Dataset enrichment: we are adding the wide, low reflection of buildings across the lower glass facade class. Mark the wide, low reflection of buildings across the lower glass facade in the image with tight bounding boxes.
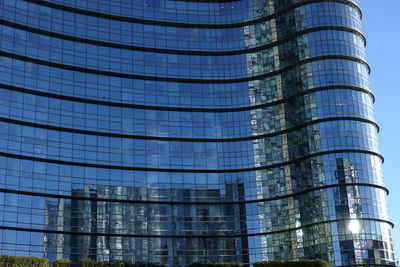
[44,183,248,264]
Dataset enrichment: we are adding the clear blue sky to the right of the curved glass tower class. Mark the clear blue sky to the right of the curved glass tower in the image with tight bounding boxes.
[360,0,400,260]
